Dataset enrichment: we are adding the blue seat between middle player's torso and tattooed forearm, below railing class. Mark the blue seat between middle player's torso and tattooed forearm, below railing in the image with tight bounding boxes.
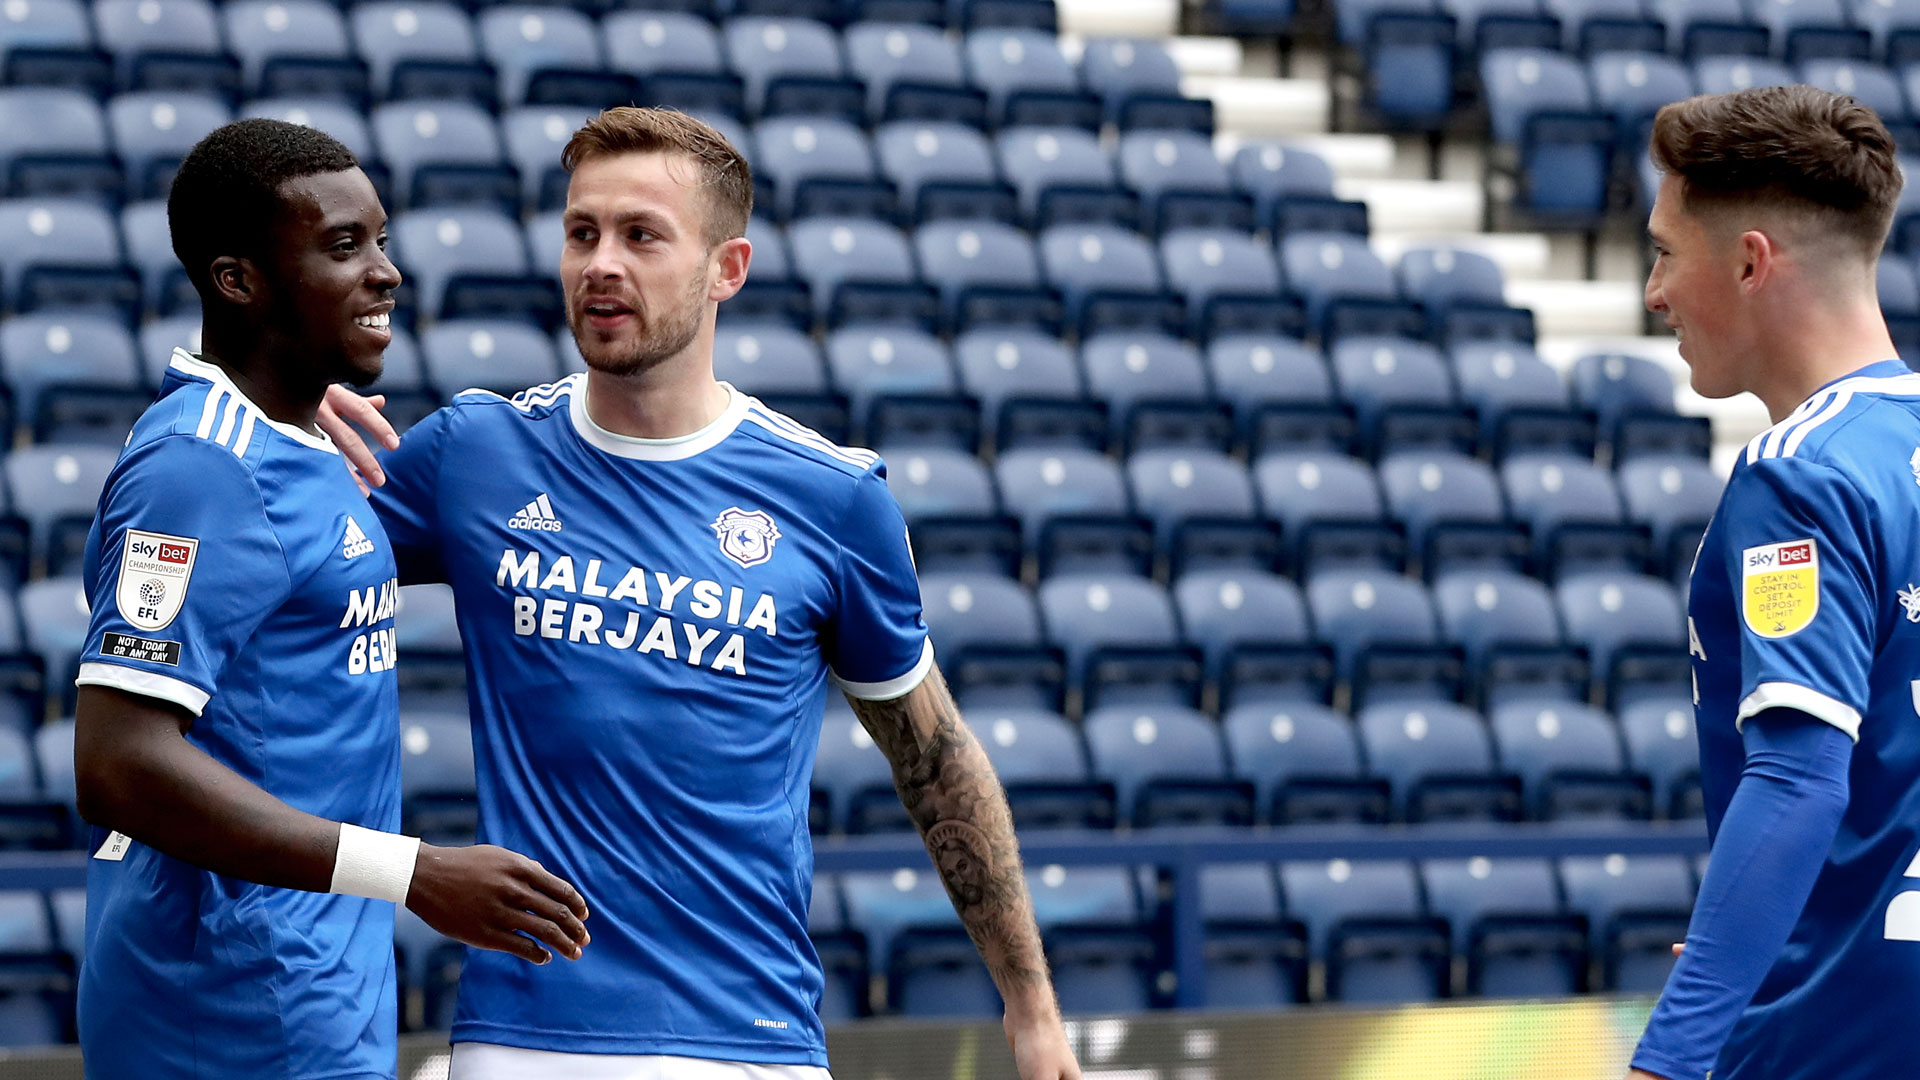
[841,867,1002,1017]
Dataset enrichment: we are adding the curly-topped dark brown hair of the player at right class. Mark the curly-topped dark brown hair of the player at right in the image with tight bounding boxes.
[1649,86,1903,259]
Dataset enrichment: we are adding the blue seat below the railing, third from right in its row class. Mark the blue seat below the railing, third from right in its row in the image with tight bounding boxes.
[1281,859,1450,1005]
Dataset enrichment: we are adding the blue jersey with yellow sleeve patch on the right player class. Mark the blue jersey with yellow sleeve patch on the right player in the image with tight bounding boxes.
[1688,361,1920,1080]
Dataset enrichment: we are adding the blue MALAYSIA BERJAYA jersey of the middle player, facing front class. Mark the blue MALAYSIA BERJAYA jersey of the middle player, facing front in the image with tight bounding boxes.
[374,375,933,1065]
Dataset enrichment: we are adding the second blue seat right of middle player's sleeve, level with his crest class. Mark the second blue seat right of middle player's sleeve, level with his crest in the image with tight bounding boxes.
[993,446,1154,578]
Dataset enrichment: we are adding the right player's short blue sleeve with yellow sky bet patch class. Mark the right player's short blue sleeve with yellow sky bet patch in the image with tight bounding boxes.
[1720,457,1880,738]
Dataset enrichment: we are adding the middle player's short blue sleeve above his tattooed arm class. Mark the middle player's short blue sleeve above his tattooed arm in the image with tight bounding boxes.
[824,463,933,701]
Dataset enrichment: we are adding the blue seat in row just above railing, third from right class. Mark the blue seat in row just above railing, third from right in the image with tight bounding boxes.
[1354,701,1523,822]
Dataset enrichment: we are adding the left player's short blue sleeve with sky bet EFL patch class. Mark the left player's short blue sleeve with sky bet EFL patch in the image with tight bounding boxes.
[75,436,292,717]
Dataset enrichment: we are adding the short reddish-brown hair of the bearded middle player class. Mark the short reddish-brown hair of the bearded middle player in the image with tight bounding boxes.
[561,106,753,246]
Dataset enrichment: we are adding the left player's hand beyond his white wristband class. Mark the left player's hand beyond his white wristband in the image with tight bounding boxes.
[407,844,591,965]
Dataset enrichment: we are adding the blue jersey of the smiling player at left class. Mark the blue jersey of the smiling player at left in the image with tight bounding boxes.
[79,352,399,1080]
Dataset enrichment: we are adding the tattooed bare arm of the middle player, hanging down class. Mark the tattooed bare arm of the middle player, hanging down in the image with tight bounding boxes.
[849,667,1079,1080]
